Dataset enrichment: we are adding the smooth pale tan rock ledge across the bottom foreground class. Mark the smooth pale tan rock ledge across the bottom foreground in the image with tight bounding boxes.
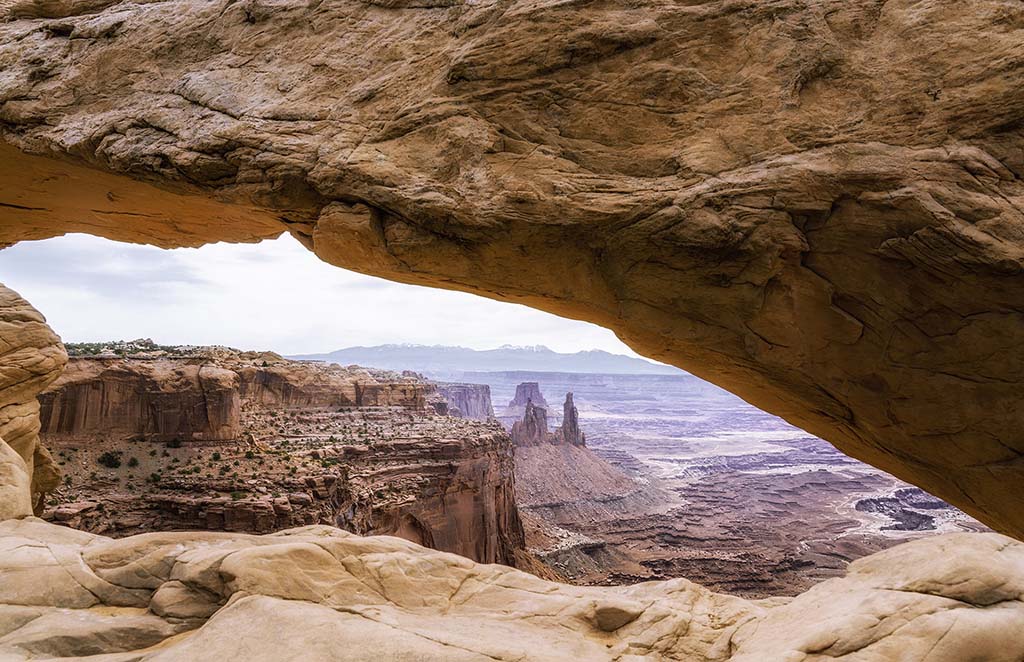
[0,519,1024,662]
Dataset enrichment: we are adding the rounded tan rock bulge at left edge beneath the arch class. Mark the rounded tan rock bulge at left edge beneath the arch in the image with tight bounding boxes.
[0,284,68,520]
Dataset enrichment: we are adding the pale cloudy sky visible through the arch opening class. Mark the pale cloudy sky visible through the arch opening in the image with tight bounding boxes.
[0,235,637,356]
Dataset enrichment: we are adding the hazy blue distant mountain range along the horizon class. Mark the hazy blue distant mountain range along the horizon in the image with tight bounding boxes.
[289,344,684,375]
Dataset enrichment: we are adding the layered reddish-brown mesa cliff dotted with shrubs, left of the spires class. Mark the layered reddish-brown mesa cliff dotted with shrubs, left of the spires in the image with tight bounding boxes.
[40,349,524,564]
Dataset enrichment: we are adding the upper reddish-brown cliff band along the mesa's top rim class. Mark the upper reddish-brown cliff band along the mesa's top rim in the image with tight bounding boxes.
[39,349,434,442]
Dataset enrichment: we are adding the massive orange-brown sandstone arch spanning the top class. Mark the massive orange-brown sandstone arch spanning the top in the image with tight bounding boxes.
[0,0,1024,537]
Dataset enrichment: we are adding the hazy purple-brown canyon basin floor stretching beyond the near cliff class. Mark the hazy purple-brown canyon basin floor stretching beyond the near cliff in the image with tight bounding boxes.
[491,371,987,598]
